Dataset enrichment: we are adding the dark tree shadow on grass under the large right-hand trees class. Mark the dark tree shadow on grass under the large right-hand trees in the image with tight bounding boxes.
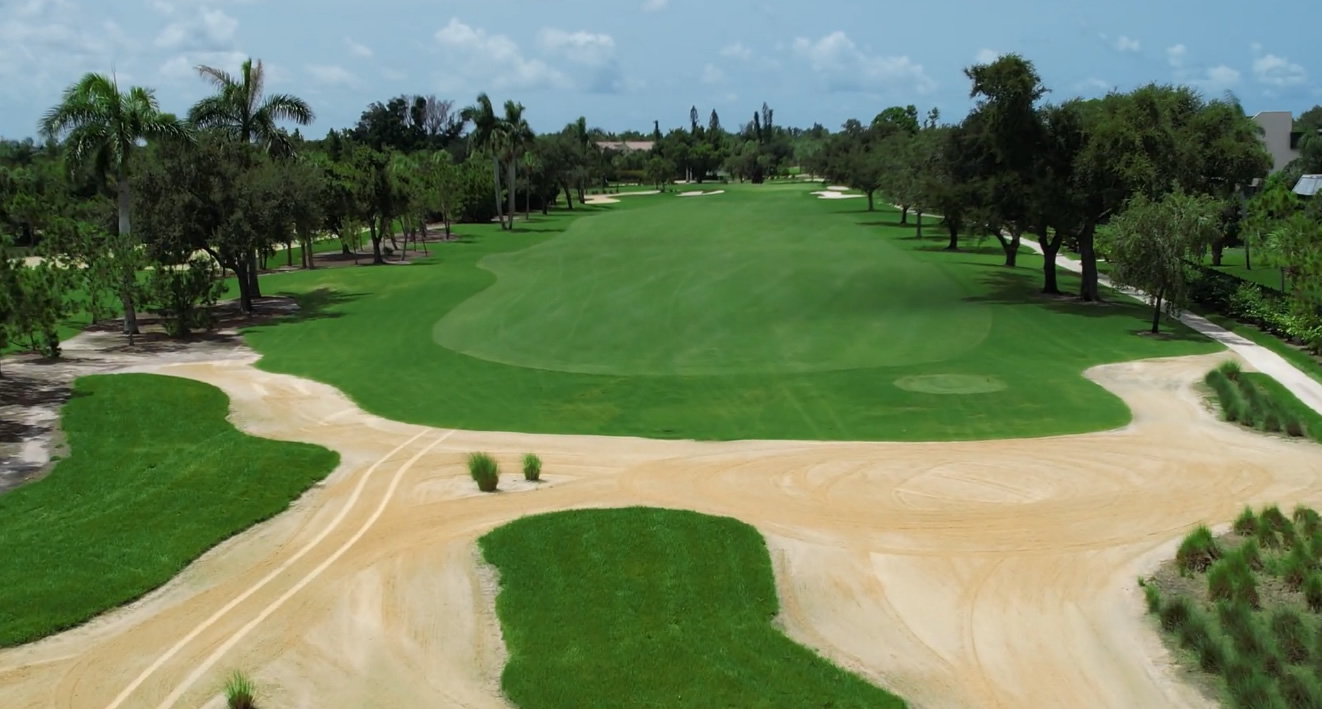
[964,266,1206,343]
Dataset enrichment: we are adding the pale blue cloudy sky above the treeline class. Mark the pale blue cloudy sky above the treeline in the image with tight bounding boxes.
[0,0,1322,138]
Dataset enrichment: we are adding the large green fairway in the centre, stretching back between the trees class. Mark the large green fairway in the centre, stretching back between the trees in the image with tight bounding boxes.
[240,183,1219,440]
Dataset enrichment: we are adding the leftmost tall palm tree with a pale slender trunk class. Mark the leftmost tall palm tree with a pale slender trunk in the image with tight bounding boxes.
[38,73,189,335]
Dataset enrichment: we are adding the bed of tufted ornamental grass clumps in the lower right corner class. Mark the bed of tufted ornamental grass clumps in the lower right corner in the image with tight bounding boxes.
[1140,507,1322,709]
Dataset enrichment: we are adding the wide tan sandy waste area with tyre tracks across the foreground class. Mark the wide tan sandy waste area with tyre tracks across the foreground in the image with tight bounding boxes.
[0,346,1322,709]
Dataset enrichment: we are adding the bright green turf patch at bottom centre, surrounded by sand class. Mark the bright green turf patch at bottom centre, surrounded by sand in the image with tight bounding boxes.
[480,508,904,709]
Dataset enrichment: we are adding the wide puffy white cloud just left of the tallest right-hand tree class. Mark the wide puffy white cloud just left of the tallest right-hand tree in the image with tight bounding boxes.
[792,30,936,94]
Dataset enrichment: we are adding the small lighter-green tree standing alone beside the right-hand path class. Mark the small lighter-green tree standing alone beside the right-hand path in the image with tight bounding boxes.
[1107,190,1222,333]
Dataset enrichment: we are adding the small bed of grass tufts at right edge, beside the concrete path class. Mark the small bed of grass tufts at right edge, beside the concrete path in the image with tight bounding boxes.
[1203,361,1322,440]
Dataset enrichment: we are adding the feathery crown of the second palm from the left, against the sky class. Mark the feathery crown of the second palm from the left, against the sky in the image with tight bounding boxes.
[188,60,316,153]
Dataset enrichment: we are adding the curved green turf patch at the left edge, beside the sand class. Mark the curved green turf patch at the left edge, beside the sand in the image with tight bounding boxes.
[0,374,338,647]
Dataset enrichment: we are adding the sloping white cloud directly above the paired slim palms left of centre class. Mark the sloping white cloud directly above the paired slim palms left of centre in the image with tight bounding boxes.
[435,17,570,90]
